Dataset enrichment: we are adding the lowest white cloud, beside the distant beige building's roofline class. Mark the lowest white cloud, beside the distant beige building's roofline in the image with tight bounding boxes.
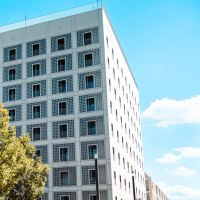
[157,182,200,200]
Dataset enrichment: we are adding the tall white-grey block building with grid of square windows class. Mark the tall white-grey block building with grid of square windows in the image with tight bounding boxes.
[0,4,146,200]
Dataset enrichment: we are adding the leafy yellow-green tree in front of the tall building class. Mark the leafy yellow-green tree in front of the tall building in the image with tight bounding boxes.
[0,104,49,200]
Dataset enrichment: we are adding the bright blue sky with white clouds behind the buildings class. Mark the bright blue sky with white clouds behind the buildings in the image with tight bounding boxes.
[0,0,200,200]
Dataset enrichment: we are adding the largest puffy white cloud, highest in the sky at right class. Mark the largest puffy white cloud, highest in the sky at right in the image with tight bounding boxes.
[142,95,200,127]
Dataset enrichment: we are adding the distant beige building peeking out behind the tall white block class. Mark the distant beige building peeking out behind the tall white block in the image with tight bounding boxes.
[145,173,169,200]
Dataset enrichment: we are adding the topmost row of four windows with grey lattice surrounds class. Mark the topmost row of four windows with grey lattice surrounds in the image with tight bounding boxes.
[4,27,99,62]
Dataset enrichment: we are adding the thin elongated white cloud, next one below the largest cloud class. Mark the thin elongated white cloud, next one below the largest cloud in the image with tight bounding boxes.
[155,147,200,164]
